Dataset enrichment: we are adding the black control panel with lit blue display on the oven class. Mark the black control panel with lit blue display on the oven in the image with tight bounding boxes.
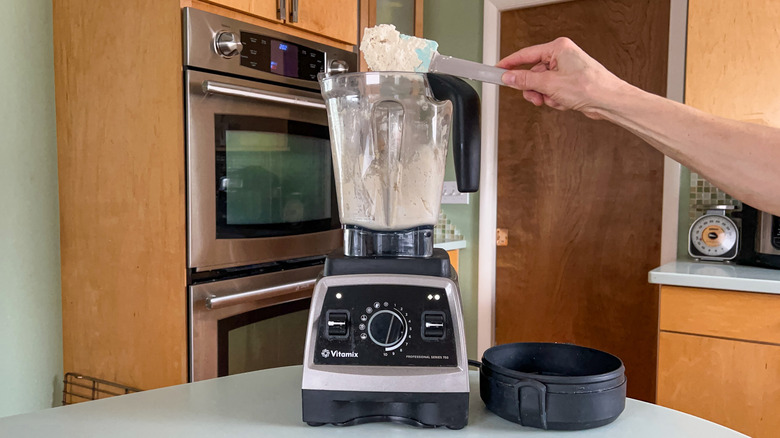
[241,32,325,81]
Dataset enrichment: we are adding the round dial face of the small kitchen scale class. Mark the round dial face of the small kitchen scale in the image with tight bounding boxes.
[689,214,738,260]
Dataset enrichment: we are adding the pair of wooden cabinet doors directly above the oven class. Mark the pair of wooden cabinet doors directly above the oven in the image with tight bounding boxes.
[197,0,358,44]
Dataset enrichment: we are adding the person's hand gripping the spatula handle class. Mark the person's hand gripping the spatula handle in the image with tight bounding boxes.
[497,38,628,119]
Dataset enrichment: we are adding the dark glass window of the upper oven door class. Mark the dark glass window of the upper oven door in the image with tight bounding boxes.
[215,114,339,239]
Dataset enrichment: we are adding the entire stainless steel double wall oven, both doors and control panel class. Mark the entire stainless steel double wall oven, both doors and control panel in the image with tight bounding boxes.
[183,8,357,381]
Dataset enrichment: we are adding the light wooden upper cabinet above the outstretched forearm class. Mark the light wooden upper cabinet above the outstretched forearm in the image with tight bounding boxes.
[685,0,780,126]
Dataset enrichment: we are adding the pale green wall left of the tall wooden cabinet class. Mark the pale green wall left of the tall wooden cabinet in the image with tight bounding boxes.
[0,0,62,416]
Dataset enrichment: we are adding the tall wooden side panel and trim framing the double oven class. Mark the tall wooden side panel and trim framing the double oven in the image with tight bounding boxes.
[53,0,358,396]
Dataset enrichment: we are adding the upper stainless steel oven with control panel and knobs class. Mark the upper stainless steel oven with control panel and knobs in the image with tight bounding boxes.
[184,8,357,271]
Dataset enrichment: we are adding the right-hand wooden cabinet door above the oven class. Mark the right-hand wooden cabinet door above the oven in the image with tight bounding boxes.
[287,0,358,44]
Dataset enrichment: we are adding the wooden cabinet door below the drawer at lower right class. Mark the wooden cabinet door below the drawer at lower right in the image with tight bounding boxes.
[656,331,780,438]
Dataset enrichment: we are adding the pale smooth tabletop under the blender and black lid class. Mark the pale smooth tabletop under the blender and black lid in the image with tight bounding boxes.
[0,366,744,438]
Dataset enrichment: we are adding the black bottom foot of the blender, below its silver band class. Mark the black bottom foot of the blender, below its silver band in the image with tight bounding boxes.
[302,390,469,429]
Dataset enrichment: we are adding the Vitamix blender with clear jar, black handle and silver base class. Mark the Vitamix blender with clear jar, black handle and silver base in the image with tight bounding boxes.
[302,72,480,429]
